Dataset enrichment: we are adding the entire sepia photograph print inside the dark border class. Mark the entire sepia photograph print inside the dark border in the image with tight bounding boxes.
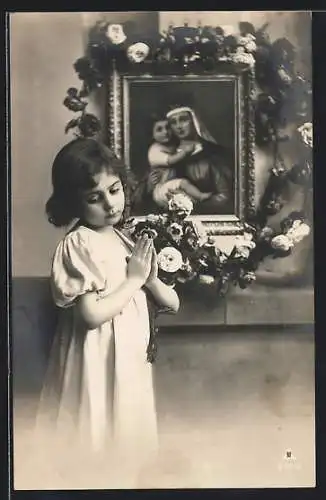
[7,10,316,491]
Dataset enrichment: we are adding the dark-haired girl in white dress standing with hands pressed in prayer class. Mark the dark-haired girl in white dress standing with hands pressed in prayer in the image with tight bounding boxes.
[38,138,179,488]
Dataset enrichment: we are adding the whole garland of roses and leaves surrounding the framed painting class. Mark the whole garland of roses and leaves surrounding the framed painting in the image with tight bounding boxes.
[64,21,312,295]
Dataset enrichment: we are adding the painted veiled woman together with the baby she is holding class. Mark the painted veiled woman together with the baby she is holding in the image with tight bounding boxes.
[129,81,235,215]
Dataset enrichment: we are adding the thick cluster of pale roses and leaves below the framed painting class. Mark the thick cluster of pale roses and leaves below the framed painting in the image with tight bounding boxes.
[123,193,310,297]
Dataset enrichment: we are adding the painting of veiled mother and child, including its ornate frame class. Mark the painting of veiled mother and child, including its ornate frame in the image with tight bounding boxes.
[109,65,255,234]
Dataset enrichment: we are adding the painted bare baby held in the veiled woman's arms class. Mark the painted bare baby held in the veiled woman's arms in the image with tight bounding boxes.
[148,118,212,209]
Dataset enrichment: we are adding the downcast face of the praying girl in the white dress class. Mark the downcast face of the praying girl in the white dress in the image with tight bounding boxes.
[80,170,125,229]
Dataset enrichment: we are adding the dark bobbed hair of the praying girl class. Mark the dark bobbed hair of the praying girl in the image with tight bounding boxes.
[45,138,131,227]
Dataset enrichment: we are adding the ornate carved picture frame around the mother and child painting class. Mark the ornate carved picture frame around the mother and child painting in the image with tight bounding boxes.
[108,63,256,235]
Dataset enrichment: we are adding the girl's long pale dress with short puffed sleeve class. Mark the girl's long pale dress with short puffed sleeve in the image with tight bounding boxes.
[36,226,157,486]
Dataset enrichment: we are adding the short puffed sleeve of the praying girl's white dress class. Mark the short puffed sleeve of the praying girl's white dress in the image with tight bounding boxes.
[51,231,106,307]
